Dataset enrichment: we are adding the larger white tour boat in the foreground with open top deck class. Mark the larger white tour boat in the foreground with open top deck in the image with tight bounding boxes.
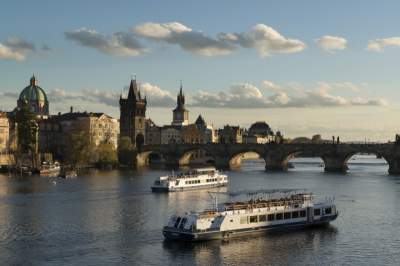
[163,190,338,241]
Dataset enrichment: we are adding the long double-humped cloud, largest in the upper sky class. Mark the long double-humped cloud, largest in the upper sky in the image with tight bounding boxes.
[133,22,306,57]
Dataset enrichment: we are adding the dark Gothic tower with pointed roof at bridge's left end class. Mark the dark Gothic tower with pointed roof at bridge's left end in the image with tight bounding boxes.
[119,78,147,147]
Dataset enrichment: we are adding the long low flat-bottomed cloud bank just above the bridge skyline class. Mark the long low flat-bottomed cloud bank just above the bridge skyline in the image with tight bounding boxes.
[192,80,388,109]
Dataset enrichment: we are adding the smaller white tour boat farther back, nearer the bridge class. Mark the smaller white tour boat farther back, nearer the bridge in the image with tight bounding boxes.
[151,167,228,192]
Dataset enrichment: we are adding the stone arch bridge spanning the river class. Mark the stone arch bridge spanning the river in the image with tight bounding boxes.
[135,143,400,174]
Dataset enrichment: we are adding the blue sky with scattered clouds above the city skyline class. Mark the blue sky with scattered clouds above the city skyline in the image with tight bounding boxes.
[0,0,400,141]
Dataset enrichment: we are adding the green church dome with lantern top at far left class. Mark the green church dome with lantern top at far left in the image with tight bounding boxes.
[17,76,49,115]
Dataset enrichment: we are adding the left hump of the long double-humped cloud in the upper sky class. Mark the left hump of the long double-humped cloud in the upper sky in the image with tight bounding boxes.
[133,22,235,56]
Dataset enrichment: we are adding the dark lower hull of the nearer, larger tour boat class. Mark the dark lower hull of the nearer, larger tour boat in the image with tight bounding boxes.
[163,214,338,242]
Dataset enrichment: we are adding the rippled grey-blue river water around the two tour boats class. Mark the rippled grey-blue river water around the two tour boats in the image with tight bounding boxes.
[0,155,400,265]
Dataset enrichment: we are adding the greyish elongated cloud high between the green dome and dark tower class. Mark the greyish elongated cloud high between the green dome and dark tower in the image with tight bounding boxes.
[64,28,147,56]
